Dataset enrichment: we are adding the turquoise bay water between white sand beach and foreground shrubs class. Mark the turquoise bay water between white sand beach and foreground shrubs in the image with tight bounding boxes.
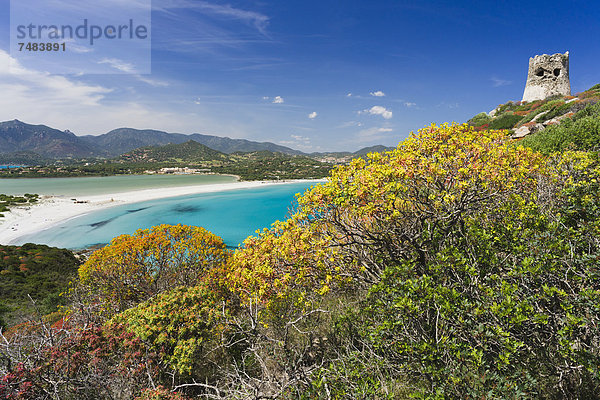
[14,182,314,249]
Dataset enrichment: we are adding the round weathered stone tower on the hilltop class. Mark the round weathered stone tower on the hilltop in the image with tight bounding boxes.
[523,51,571,101]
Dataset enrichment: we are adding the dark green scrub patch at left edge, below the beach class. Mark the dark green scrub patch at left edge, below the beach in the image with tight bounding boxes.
[0,243,80,328]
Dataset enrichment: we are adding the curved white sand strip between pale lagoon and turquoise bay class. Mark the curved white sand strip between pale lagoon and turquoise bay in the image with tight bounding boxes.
[0,179,326,245]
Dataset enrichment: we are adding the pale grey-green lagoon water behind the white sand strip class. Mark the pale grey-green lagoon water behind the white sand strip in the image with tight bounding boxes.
[0,175,236,196]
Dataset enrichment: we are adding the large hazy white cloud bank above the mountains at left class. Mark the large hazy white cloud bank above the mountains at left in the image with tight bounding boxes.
[0,50,218,135]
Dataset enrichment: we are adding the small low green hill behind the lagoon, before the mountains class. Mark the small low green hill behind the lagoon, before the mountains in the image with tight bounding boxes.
[119,140,228,163]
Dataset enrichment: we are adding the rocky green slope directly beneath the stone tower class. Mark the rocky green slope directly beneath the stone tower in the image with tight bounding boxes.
[467,84,600,138]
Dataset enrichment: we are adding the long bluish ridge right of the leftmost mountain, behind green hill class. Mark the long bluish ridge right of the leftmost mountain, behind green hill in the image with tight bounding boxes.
[81,128,302,157]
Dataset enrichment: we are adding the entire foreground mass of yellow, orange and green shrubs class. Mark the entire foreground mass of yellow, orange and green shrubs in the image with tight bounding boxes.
[0,121,600,399]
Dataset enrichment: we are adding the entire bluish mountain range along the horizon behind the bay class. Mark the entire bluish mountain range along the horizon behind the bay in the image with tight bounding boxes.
[0,119,389,163]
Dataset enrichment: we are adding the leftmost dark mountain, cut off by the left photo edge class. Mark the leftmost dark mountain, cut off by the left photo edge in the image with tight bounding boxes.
[0,119,97,158]
